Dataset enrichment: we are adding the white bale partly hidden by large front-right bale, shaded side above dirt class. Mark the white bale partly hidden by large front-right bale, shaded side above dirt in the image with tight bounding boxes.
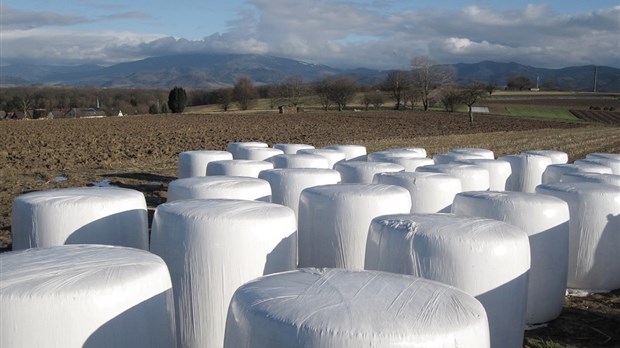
[452,192,569,324]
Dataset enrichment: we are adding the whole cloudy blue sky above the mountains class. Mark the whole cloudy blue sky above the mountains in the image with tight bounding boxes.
[0,0,620,69]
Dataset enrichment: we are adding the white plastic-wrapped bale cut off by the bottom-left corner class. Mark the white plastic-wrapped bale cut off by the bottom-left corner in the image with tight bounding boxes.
[0,244,176,348]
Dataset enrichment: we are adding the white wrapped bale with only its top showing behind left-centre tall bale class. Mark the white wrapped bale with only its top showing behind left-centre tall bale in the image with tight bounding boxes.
[168,176,271,202]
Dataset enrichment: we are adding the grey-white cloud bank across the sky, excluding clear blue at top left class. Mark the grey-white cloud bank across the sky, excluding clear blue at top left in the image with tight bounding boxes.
[2,0,620,69]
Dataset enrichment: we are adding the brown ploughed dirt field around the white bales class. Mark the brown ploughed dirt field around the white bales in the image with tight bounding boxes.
[0,112,620,347]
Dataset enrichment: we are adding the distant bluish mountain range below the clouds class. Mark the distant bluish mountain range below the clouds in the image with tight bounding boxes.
[0,54,620,92]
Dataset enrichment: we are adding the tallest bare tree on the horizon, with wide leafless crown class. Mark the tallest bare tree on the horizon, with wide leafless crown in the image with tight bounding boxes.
[411,56,456,110]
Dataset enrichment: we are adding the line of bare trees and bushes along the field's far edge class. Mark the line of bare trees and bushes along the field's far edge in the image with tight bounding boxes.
[0,56,532,122]
